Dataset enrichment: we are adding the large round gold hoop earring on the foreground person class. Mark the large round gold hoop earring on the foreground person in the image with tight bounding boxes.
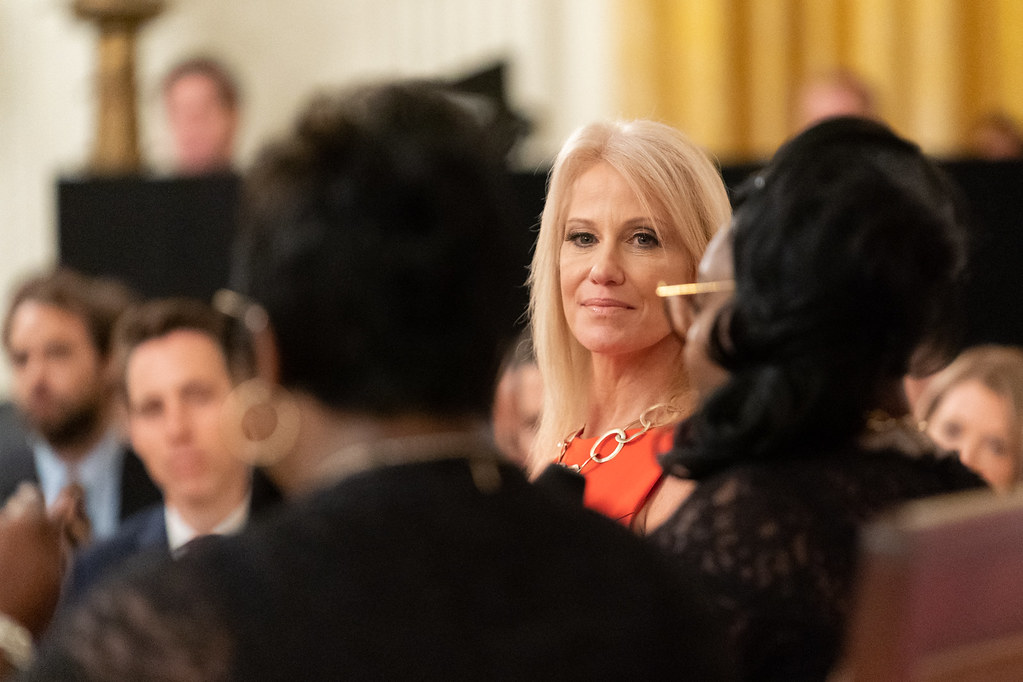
[221,378,301,466]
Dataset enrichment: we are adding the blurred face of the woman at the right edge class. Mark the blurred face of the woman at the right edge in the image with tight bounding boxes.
[927,379,1019,492]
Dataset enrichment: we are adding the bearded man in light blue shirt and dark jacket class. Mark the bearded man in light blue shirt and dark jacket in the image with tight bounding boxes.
[0,269,160,538]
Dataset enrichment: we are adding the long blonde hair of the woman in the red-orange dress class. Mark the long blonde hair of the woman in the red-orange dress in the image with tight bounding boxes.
[529,121,731,470]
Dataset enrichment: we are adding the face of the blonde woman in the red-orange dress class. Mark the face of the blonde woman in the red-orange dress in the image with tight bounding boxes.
[559,162,692,355]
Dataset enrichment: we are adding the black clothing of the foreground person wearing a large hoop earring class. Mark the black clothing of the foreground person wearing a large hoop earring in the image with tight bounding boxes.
[28,459,729,680]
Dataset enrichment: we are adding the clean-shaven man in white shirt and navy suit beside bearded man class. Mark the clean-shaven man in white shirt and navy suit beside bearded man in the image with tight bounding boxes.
[68,299,278,601]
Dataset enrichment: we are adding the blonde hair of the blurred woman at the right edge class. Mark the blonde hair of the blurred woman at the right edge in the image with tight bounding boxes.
[916,345,1023,482]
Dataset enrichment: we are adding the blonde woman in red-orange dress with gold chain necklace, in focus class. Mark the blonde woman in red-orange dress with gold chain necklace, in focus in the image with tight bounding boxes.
[530,121,730,526]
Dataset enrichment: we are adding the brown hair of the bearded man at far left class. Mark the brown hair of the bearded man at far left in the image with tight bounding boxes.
[3,267,134,359]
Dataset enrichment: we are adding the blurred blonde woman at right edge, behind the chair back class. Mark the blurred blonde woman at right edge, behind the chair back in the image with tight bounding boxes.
[917,346,1023,492]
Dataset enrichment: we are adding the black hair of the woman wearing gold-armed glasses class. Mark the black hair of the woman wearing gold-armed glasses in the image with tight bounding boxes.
[697,118,966,466]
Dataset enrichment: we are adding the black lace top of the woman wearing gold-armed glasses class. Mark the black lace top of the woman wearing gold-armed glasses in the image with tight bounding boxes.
[651,435,983,680]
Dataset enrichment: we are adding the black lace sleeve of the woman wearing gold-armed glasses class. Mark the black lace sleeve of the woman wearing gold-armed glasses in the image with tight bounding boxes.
[651,468,855,680]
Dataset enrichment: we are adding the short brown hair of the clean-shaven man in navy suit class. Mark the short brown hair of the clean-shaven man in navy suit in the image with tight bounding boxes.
[114,298,255,382]
